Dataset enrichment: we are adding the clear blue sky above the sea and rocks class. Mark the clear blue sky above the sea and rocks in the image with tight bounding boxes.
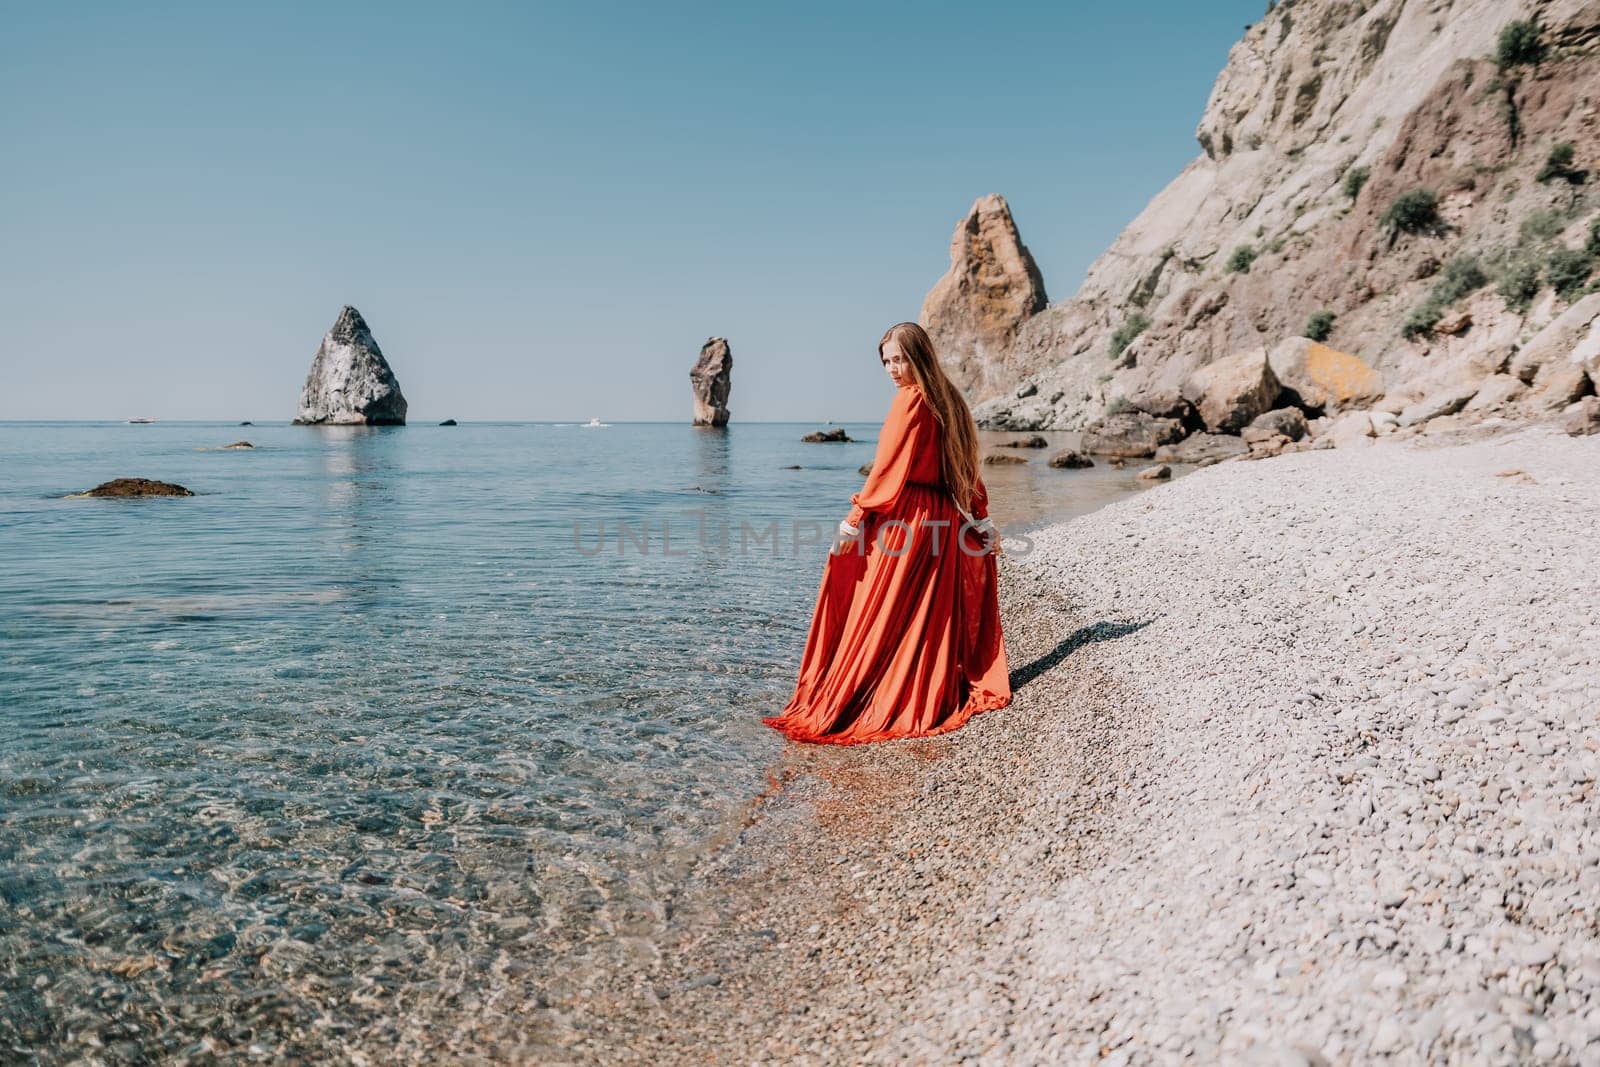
[0,0,1266,421]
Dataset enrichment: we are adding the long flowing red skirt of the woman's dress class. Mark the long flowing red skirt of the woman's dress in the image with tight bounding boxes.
[762,485,1011,744]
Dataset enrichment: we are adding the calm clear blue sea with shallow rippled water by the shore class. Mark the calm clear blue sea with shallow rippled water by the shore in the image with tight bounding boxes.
[0,422,1177,1062]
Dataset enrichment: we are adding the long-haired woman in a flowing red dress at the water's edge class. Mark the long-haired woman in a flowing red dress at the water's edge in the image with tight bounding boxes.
[763,323,1011,744]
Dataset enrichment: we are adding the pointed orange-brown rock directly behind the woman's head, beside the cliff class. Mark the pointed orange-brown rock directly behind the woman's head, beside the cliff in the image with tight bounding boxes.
[918,194,1050,400]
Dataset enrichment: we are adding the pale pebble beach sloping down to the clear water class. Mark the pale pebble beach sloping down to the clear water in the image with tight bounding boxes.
[540,427,1600,1064]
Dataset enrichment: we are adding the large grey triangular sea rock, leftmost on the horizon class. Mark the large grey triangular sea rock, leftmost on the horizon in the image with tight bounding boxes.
[294,304,406,426]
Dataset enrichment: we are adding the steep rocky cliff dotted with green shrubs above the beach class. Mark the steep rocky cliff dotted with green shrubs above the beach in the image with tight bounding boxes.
[947,0,1600,438]
